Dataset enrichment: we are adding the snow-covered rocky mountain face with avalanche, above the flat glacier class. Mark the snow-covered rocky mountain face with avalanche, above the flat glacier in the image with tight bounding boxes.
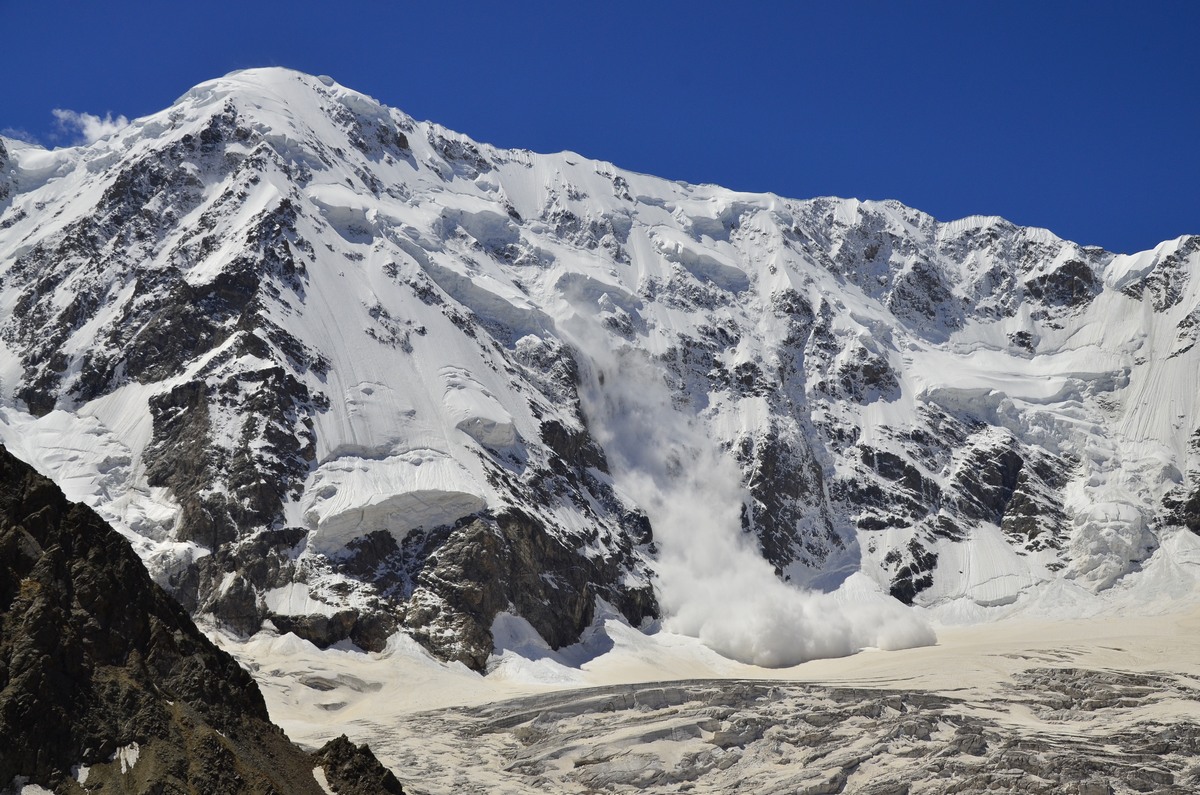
[0,68,1200,668]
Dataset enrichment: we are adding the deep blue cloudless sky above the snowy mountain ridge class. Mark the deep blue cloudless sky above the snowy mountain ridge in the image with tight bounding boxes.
[0,0,1200,251]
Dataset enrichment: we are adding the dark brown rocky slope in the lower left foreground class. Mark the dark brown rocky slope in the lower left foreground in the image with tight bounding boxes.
[0,448,403,795]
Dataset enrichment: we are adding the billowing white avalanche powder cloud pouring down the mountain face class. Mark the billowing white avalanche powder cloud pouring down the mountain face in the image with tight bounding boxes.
[575,323,936,668]
